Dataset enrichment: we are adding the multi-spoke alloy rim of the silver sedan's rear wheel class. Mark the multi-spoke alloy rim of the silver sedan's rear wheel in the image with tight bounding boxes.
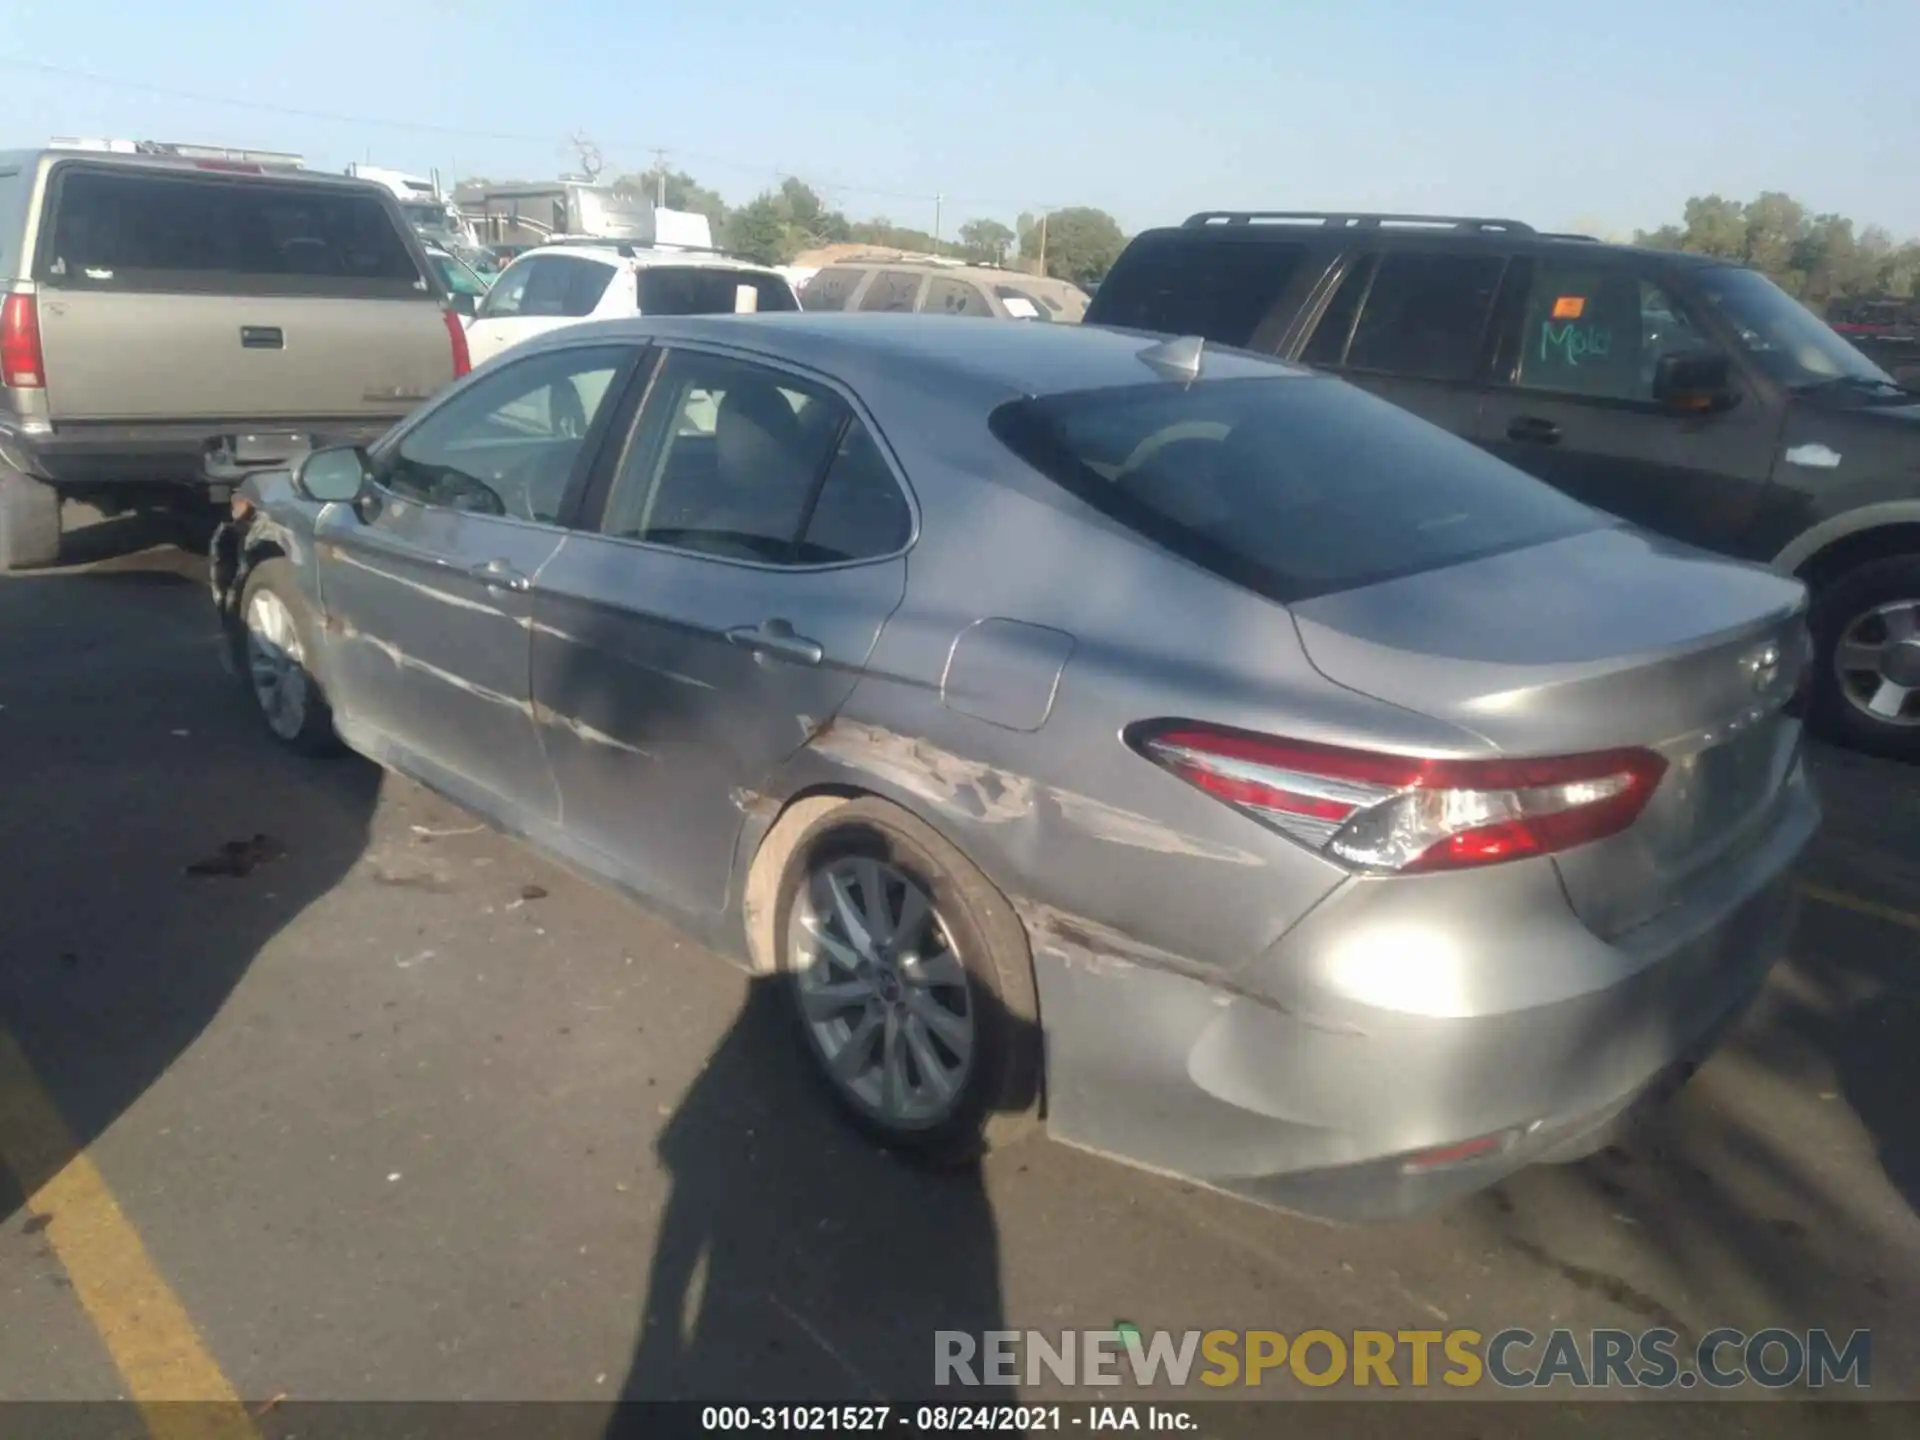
[787,856,973,1129]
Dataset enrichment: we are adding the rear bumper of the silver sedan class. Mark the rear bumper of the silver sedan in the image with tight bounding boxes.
[1033,772,1818,1221]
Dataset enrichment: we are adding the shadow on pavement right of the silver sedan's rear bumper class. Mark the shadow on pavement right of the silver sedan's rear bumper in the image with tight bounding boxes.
[1463,756,1920,1398]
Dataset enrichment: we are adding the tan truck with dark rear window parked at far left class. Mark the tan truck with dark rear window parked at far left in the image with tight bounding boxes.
[0,142,467,570]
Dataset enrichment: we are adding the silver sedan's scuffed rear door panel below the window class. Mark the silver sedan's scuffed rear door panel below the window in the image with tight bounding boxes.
[532,534,906,914]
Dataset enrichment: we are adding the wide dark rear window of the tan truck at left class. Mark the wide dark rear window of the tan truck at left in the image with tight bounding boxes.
[38,169,432,300]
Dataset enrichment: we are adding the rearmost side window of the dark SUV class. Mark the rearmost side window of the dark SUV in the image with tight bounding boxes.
[1087,230,1308,346]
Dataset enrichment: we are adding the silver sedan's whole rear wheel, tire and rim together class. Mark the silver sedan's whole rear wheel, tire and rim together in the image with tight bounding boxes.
[774,799,1041,1169]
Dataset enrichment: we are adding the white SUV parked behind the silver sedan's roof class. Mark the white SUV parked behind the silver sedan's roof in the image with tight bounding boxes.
[467,240,801,365]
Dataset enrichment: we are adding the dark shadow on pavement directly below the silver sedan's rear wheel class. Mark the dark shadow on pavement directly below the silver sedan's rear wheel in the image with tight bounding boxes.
[611,979,1012,1413]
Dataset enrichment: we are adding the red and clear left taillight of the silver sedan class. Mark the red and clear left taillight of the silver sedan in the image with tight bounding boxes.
[1133,722,1667,874]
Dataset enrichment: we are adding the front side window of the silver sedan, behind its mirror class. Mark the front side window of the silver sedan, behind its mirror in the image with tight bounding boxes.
[380,346,632,524]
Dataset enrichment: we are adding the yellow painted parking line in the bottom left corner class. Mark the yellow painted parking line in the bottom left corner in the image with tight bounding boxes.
[0,1031,259,1440]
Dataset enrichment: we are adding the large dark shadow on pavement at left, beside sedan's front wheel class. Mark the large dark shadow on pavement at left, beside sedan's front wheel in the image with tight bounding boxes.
[0,545,380,1223]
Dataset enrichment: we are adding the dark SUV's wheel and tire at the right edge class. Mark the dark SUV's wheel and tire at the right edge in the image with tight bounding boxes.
[1809,555,1920,760]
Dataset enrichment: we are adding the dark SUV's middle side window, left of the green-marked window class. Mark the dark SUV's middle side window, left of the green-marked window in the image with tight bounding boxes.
[1346,252,1507,380]
